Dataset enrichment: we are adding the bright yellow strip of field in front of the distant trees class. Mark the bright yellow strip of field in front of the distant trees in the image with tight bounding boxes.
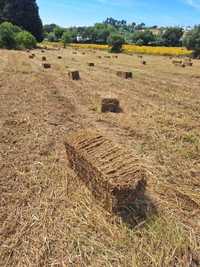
[71,44,192,56]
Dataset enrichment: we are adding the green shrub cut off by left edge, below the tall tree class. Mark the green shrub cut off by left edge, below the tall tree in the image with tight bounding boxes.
[0,22,16,49]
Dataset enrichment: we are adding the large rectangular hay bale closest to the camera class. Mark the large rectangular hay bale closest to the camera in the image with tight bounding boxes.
[64,130,148,213]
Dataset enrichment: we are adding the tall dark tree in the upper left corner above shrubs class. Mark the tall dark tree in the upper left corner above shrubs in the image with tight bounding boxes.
[0,0,43,41]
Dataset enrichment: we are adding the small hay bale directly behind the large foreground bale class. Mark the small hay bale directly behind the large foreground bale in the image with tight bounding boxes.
[101,97,121,113]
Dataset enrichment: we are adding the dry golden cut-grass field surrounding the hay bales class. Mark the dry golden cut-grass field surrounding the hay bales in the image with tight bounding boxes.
[0,48,200,267]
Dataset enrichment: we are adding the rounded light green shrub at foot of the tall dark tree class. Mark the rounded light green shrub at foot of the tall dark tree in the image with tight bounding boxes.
[16,31,37,49]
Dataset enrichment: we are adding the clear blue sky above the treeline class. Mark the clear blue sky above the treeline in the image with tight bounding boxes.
[37,0,200,26]
